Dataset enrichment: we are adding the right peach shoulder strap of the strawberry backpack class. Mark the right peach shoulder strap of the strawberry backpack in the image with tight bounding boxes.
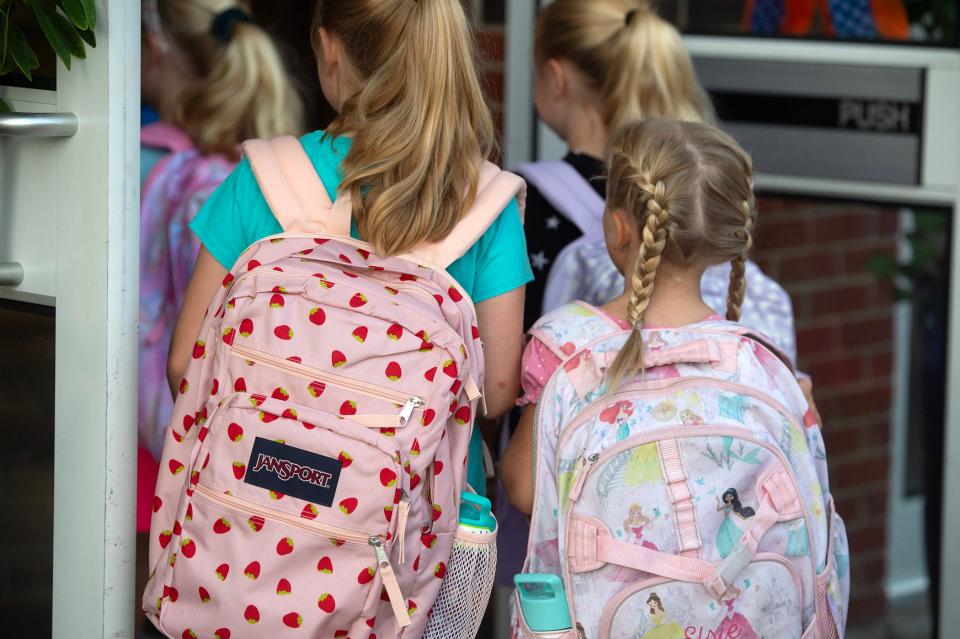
[412,162,526,268]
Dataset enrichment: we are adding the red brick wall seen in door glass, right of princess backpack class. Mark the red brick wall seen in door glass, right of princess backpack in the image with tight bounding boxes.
[755,198,897,621]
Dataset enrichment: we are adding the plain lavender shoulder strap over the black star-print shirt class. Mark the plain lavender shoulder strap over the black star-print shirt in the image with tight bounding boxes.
[517,160,604,235]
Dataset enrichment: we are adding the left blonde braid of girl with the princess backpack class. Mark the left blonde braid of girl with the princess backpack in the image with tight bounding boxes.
[608,175,670,390]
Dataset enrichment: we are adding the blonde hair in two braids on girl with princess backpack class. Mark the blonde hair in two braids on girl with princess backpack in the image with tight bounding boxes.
[607,120,756,389]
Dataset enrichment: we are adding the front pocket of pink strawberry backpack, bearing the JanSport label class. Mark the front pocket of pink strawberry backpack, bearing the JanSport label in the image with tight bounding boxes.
[160,394,407,637]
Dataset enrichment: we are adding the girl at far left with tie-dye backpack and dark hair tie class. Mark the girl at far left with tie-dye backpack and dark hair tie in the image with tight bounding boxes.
[137,0,301,624]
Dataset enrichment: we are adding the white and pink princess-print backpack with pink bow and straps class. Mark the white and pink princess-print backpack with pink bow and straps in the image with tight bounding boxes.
[514,304,850,639]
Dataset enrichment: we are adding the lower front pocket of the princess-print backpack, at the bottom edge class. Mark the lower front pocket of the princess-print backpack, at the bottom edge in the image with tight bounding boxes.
[599,553,802,639]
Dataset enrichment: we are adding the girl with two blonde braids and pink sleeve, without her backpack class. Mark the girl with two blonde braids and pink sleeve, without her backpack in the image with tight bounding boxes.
[501,120,756,513]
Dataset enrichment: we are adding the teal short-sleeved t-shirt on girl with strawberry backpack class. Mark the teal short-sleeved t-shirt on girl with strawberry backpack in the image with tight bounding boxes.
[190,131,533,494]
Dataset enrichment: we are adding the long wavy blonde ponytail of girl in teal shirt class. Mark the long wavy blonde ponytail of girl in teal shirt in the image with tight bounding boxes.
[313,0,494,255]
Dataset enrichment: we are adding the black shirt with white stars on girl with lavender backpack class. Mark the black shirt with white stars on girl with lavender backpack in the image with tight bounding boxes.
[523,152,607,330]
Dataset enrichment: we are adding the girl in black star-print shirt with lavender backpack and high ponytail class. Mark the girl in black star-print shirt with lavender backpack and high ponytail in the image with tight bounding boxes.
[520,0,796,370]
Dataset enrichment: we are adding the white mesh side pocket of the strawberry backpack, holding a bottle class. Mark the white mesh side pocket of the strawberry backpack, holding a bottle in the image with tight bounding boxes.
[423,531,497,639]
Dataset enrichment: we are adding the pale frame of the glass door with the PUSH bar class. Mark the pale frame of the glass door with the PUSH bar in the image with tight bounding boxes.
[504,5,960,638]
